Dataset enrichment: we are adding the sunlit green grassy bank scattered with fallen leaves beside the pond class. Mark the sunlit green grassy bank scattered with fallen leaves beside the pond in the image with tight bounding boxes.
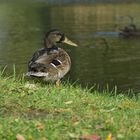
[0,72,140,140]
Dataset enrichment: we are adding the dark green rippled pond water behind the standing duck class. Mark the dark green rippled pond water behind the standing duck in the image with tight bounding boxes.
[0,1,140,91]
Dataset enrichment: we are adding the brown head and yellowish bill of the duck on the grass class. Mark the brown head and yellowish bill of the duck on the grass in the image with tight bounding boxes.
[44,29,78,48]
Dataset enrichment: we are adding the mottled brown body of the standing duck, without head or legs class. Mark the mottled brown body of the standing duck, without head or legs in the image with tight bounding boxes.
[27,48,71,80]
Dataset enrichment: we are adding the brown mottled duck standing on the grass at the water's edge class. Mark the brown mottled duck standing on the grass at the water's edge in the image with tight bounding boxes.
[26,29,78,85]
